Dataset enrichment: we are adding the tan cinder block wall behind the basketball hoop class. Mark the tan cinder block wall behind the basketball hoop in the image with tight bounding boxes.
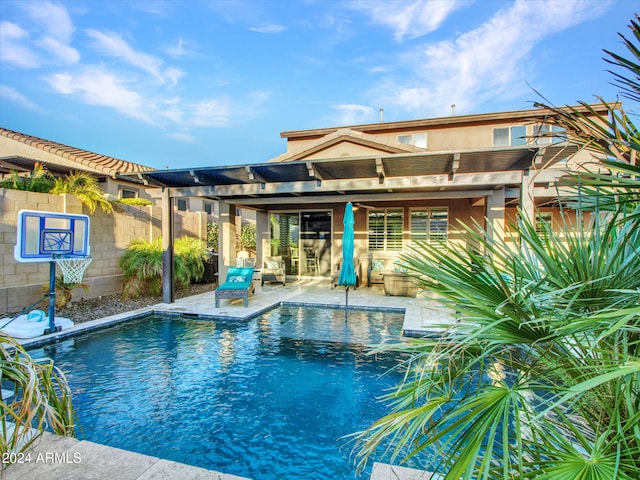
[0,188,208,315]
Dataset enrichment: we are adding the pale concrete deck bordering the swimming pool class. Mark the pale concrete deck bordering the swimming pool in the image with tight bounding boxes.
[7,279,454,480]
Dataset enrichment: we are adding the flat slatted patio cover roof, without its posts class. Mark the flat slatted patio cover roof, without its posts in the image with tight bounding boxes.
[122,143,577,205]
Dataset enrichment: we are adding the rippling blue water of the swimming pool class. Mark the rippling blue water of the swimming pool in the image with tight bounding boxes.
[31,306,424,480]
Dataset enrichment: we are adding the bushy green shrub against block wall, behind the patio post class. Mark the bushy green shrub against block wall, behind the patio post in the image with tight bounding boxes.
[119,235,208,298]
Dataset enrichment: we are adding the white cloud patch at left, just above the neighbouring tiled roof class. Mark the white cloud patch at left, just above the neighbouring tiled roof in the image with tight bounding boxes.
[46,67,154,124]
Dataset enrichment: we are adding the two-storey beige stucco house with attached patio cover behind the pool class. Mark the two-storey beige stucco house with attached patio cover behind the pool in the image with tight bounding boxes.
[124,105,598,301]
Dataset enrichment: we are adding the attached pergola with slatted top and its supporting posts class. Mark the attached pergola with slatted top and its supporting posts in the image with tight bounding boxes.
[123,143,576,303]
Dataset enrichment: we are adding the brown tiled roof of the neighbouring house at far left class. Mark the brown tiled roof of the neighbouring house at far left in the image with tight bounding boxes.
[0,127,154,178]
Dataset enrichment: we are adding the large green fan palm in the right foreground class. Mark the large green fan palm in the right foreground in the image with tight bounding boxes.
[356,15,640,480]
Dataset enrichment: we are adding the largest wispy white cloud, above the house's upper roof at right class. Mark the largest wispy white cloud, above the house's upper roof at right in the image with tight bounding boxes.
[377,0,602,115]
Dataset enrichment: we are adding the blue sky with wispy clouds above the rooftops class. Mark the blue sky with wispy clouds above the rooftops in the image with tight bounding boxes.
[0,0,638,168]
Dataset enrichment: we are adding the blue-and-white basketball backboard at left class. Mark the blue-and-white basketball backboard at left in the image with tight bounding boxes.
[13,210,90,262]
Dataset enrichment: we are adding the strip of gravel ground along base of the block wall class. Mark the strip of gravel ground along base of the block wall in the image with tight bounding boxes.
[2,283,216,323]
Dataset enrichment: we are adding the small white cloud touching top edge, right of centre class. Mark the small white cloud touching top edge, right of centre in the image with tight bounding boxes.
[351,0,468,41]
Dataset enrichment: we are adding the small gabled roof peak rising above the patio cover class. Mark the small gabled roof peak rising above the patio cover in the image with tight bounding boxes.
[269,128,426,162]
